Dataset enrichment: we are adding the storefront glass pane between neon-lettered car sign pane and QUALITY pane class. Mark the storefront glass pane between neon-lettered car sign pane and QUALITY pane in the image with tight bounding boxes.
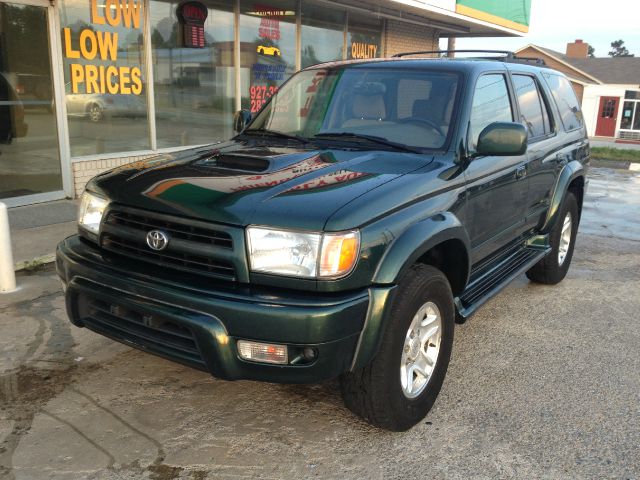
[302,2,346,68]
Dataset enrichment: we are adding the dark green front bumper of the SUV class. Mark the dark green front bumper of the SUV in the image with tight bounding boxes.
[56,236,386,383]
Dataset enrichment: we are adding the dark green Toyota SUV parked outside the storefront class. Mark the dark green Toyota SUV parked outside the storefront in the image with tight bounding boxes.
[57,55,589,431]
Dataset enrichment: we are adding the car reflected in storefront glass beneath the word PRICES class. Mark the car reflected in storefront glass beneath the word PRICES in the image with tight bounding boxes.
[65,84,147,122]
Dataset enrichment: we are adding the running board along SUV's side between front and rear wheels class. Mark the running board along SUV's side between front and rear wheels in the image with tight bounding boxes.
[455,244,551,323]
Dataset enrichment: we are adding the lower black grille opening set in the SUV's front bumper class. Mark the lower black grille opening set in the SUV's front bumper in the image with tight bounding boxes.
[78,294,206,369]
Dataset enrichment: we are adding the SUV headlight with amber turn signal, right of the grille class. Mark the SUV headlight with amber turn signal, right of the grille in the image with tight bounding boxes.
[247,227,360,278]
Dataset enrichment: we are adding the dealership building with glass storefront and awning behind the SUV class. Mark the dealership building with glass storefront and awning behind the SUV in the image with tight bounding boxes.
[0,0,530,206]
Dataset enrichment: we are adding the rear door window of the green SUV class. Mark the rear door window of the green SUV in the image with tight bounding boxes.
[513,75,551,139]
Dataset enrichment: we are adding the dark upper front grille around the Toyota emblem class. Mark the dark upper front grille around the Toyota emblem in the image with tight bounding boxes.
[100,207,238,281]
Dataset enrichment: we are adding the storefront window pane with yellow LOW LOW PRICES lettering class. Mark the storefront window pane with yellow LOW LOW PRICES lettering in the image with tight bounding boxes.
[60,0,150,157]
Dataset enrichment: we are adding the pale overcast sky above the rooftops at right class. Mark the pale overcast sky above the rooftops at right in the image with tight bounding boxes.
[440,0,640,57]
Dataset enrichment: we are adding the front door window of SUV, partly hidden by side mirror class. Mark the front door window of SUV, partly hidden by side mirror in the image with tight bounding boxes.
[469,74,513,150]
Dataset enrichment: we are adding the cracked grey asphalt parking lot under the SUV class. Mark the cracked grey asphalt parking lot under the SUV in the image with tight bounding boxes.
[0,169,640,480]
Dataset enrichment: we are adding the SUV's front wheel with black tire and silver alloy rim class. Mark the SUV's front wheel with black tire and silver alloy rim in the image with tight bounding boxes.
[340,265,455,432]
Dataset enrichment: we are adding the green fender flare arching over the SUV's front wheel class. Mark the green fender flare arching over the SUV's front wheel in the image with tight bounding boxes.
[373,212,471,285]
